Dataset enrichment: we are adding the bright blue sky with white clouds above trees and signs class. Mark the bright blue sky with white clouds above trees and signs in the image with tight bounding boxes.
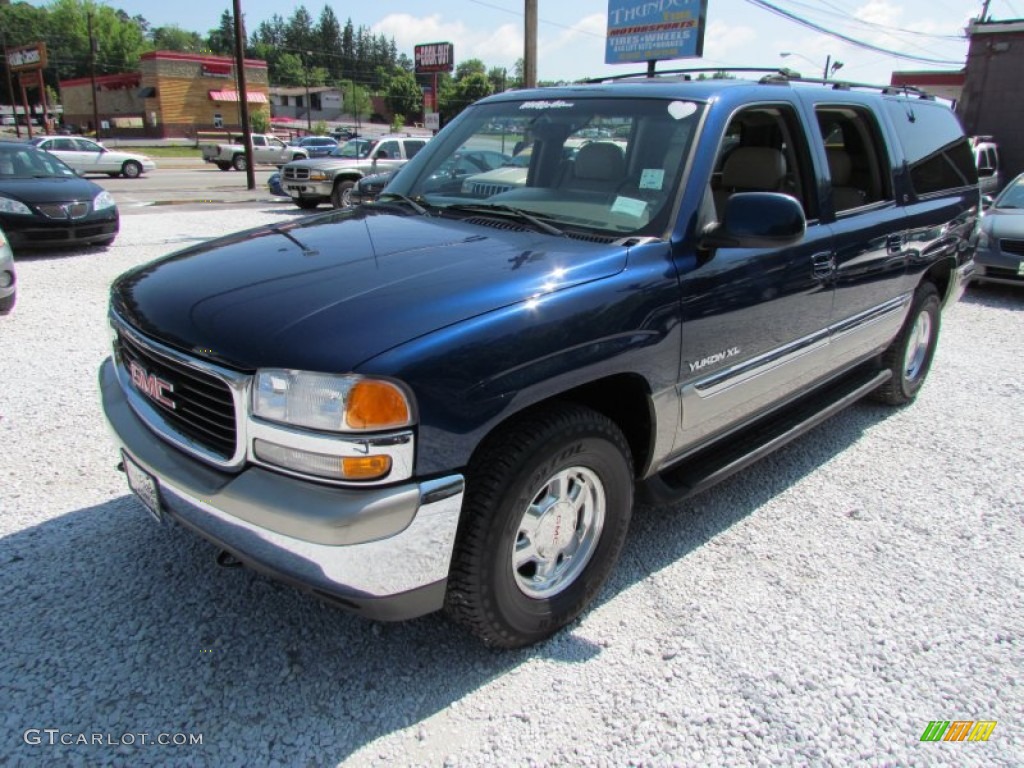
[25,0,1024,83]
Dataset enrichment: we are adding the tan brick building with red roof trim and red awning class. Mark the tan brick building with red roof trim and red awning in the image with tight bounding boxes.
[60,51,269,137]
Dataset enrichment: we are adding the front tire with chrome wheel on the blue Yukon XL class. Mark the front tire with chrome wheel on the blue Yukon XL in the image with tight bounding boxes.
[444,403,633,648]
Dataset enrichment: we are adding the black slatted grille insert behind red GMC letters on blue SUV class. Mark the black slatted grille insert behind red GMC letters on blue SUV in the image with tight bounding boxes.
[115,329,238,461]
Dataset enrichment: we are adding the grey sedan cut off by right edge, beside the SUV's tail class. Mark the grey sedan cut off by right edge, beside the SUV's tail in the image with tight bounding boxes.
[974,173,1024,287]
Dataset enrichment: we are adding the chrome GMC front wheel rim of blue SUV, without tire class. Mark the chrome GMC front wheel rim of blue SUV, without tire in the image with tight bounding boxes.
[512,467,606,600]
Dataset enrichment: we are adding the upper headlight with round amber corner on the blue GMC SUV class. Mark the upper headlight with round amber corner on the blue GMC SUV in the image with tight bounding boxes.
[252,369,413,432]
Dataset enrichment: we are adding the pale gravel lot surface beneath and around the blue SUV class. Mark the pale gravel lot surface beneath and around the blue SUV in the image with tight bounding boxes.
[0,203,1024,766]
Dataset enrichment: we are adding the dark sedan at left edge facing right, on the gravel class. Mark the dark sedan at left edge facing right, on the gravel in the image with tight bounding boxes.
[0,141,119,251]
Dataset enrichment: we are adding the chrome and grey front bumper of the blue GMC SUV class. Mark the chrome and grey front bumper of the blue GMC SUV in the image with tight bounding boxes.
[99,358,465,620]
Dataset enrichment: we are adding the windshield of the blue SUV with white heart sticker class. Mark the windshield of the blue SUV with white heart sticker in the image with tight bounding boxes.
[385,97,703,237]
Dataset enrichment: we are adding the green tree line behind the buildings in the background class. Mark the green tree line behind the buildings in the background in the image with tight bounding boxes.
[0,0,557,120]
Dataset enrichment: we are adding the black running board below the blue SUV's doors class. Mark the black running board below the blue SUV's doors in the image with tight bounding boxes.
[638,368,892,504]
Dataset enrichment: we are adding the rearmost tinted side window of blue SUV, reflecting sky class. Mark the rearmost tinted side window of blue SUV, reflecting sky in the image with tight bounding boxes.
[886,99,978,195]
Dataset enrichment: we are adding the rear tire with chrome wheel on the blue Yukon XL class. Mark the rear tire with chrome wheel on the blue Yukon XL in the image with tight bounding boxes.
[871,283,941,406]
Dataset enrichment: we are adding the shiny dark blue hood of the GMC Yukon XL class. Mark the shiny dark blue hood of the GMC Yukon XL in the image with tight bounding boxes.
[111,208,628,372]
